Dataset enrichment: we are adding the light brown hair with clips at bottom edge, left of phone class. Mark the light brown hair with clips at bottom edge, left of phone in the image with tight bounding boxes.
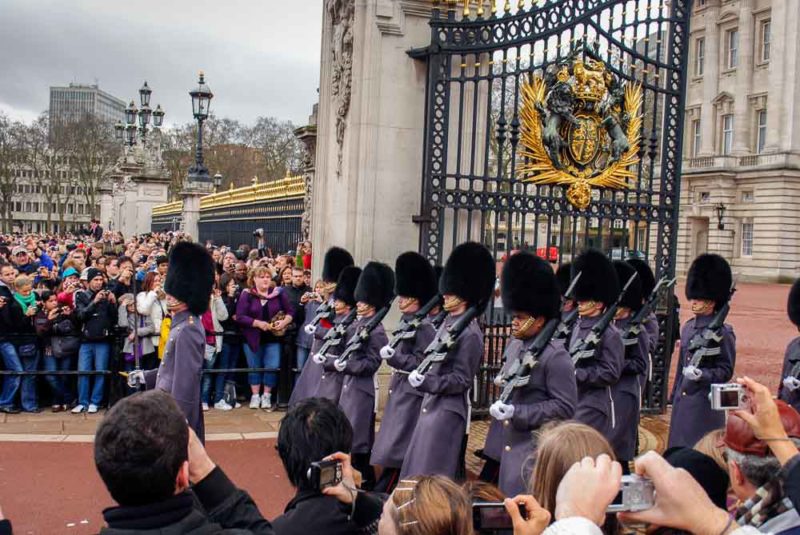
[389,476,473,535]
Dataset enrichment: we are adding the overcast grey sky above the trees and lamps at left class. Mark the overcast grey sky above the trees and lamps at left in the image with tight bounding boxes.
[0,0,322,125]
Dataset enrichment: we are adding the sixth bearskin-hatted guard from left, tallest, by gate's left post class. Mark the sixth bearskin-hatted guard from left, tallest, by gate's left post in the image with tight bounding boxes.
[400,242,495,479]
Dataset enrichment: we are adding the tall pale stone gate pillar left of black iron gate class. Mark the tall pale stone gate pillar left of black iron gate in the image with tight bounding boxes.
[311,0,431,273]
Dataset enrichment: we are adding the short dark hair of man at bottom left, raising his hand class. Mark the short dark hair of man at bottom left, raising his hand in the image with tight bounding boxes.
[94,390,189,506]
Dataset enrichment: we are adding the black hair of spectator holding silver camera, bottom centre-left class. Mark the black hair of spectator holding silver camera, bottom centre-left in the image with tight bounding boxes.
[278,398,353,490]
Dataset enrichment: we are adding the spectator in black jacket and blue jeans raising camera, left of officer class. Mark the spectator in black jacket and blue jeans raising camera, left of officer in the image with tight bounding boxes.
[72,268,117,414]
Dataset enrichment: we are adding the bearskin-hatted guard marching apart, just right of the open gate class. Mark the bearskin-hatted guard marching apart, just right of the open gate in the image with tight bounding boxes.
[668,254,736,448]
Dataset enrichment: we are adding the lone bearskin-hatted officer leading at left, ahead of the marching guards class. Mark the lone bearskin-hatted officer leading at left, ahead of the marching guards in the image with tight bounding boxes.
[128,242,214,441]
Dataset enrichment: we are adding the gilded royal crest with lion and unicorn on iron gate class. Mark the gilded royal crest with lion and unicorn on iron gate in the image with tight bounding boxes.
[518,50,642,209]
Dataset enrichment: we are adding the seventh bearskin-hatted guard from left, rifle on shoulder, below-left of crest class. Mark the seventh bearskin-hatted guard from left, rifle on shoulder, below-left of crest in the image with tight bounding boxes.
[489,252,578,496]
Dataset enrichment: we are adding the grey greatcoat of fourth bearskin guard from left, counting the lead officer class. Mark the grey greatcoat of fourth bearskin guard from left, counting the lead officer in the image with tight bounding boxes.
[338,318,389,453]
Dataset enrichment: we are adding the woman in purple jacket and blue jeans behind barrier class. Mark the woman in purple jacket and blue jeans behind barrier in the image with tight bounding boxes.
[236,266,294,409]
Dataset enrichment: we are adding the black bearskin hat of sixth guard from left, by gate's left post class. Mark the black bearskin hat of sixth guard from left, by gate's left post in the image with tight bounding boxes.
[439,242,495,309]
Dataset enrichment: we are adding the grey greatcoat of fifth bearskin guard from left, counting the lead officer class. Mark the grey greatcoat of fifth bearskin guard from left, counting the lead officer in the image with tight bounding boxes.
[370,314,436,468]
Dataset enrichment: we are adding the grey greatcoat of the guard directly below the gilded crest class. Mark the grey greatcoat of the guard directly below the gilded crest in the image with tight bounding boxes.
[570,316,624,439]
